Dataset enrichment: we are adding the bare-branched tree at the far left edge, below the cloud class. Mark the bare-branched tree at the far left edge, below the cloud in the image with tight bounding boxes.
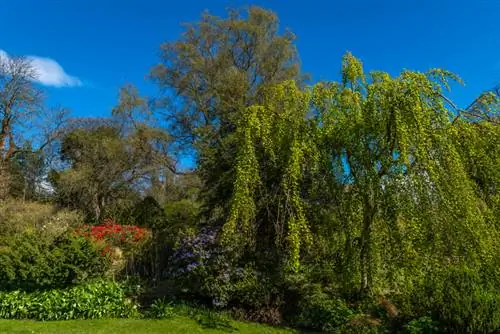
[0,54,68,198]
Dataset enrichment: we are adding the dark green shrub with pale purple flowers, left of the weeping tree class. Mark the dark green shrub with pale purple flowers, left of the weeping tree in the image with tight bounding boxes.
[170,228,284,309]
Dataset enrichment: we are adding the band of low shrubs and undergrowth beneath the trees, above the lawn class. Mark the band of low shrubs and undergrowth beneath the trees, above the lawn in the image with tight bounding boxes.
[0,200,500,333]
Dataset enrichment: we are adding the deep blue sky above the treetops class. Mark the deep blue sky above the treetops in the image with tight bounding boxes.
[0,0,500,116]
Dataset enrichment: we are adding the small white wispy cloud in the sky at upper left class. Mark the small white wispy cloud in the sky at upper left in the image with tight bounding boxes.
[0,49,82,87]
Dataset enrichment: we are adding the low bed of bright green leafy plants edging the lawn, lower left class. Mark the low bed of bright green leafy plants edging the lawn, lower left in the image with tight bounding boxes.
[0,281,138,321]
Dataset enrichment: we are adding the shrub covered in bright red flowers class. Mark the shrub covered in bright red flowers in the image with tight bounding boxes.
[75,219,151,256]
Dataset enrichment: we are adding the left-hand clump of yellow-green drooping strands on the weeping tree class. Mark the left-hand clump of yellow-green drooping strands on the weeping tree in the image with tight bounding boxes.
[224,81,316,270]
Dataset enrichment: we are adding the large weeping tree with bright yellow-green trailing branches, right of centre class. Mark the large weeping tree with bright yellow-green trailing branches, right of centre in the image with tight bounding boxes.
[224,54,496,292]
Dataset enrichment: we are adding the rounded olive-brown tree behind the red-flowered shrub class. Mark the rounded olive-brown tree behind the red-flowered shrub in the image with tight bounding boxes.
[52,122,172,221]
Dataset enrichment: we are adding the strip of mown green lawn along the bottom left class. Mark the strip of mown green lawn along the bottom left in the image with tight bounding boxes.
[0,317,295,334]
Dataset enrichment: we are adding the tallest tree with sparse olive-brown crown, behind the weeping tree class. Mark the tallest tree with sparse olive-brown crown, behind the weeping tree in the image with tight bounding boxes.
[151,7,302,215]
